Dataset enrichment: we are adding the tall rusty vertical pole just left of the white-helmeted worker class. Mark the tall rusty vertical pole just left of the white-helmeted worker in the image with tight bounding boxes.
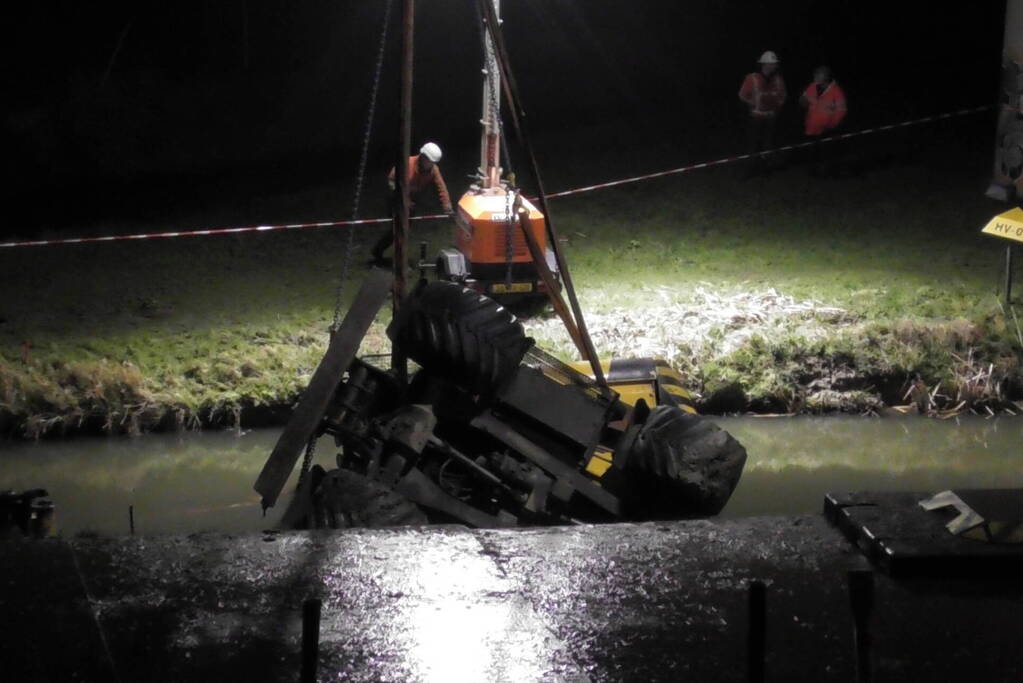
[391,0,415,383]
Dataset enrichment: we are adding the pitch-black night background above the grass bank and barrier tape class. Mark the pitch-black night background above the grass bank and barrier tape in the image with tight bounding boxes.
[3,0,1005,232]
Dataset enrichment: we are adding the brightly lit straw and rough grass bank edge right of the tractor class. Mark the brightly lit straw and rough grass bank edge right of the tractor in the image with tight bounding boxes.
[526,285,1023,416]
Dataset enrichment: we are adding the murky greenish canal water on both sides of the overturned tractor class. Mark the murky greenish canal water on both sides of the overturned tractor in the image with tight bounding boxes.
[0,417,1023,534]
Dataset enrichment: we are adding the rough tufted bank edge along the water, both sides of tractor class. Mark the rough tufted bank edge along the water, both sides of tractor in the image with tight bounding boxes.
[0,285,1023,439]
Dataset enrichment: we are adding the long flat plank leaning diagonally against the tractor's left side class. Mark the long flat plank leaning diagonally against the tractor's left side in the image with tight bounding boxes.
[253,269,393,510]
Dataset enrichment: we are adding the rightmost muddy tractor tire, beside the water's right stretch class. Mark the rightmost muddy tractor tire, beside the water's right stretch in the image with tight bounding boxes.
[625,405,746,520]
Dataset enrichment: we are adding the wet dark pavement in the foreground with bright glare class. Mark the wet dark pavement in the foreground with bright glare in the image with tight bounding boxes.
[0,516,1023,682]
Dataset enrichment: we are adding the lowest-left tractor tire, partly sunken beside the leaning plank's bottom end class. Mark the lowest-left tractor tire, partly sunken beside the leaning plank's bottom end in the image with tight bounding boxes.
[313,469,428,529]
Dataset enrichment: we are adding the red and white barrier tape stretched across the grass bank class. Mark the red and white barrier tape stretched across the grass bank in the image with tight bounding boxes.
[0,105,991,248]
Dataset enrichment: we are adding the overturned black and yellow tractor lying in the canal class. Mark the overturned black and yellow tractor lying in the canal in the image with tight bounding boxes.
[257,274,746,528]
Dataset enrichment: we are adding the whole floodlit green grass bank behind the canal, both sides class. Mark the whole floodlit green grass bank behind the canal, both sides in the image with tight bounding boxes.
[0,116,1023,437]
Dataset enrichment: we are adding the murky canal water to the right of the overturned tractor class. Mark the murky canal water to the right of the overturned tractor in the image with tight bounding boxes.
[714,417,1023,516]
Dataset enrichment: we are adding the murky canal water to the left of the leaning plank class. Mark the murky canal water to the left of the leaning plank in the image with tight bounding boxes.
[0,430,310,535]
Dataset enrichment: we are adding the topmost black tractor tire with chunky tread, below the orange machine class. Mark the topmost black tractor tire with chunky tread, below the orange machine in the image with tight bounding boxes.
[388,281,533,394]
